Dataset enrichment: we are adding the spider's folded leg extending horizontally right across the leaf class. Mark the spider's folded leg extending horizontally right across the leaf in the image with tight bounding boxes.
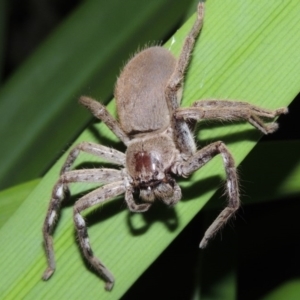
[175,99,288,134]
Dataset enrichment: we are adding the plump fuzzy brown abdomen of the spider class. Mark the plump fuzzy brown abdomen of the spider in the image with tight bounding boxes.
[115,46,176,134]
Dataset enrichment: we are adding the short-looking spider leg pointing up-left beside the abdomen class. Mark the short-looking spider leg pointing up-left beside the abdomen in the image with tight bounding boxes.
[79,96,129,145]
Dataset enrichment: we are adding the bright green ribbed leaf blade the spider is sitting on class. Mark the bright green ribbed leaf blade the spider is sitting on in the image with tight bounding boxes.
[0,0,300,299]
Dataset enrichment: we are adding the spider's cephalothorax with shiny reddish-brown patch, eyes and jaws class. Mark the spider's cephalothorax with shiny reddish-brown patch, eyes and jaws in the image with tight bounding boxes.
[126,133,179,202]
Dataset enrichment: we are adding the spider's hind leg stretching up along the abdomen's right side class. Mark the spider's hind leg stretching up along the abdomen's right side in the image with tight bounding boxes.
[165,2,204,156]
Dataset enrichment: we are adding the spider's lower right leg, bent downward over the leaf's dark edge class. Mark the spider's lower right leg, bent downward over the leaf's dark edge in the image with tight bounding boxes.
[175,142,240,248]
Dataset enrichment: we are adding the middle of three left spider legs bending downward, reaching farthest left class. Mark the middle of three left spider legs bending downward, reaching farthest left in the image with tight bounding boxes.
[42,169,122,280]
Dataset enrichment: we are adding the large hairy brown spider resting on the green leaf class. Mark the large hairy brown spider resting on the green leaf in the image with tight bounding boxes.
[43,2,288,290]
